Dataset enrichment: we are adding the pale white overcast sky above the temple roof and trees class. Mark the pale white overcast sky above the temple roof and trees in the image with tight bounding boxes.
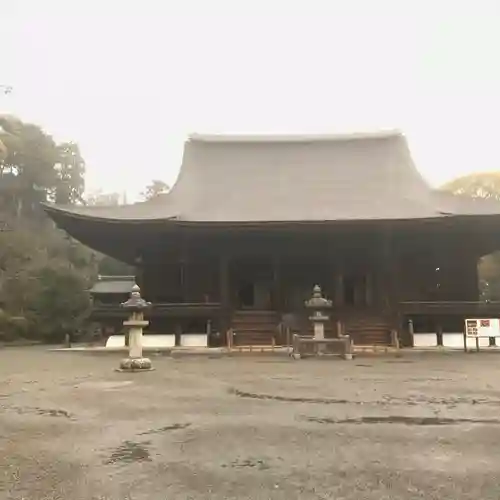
[0,0,500,198]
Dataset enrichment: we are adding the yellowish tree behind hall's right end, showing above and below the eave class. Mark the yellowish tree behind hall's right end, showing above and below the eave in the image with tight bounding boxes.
[442,171,500,300]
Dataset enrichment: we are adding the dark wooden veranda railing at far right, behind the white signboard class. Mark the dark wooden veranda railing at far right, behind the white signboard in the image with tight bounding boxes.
[399,301,500,316]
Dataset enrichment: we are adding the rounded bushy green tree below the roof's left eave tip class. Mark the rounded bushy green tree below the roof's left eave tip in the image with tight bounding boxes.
[0,225,98,340]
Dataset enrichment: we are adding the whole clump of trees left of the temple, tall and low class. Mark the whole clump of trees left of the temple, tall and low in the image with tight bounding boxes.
[0,116,94,340]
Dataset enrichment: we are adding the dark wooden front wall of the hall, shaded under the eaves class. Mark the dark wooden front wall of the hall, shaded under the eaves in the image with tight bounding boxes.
[142,223,486,310]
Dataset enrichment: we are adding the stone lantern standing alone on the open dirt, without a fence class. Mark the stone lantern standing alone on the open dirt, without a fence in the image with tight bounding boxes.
[119,284,153,372]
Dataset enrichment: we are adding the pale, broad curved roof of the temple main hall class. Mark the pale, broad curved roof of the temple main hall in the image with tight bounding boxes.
[45,132,500,223]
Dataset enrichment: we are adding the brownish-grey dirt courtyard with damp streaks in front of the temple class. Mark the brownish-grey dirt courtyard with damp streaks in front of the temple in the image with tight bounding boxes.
[0,348,500,500]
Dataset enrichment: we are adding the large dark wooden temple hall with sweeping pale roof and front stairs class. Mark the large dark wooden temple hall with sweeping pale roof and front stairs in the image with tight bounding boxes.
[45,131,500,346]
